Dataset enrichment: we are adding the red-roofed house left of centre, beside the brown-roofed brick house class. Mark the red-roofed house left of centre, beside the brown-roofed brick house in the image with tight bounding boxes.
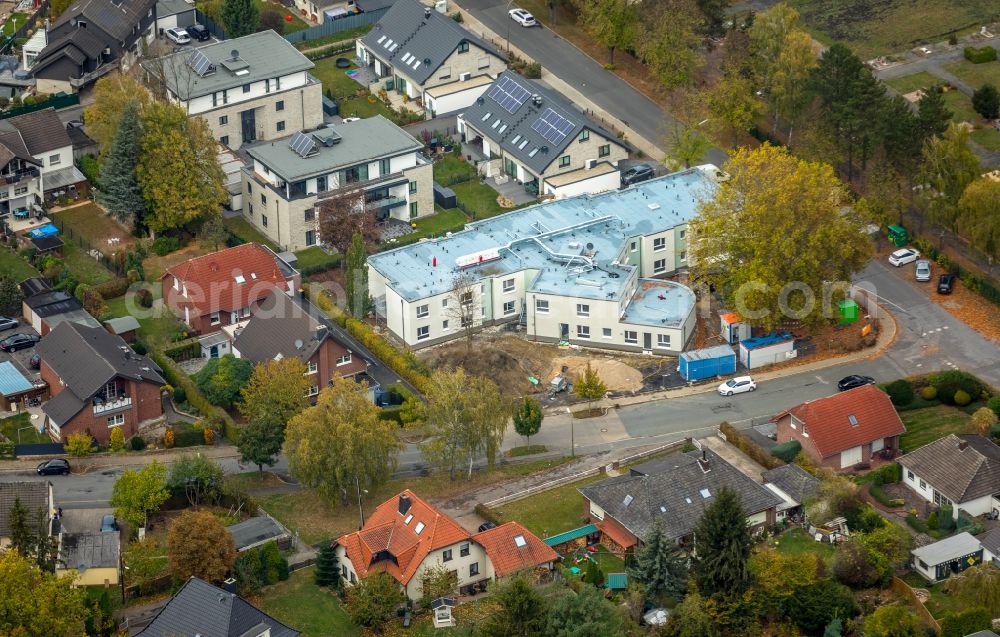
[161,243,302,334]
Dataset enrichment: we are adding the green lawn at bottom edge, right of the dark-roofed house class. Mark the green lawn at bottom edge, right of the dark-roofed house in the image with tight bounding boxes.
[260,566,361,637]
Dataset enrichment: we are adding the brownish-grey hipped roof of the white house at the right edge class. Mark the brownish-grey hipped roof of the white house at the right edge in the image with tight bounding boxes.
[898,434,1000,504]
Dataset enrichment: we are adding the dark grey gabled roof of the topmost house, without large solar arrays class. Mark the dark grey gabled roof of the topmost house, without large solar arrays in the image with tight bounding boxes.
[361,0,506,84]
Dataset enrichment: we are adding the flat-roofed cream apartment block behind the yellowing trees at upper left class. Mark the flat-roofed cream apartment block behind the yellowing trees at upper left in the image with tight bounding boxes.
[142,30,323,150]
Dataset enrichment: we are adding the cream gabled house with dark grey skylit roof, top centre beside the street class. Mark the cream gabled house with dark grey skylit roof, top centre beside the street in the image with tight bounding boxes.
[355,0,507,117]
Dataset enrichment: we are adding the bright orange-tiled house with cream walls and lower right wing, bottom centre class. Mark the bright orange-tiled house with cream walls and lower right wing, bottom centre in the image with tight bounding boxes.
[336,489,557,601]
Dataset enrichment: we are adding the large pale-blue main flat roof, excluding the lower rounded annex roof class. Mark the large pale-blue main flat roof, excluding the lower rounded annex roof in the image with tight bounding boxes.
[368,165,718,302]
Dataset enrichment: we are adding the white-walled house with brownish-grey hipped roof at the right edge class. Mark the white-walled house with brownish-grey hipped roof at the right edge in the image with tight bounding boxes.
[897,434,1000,517]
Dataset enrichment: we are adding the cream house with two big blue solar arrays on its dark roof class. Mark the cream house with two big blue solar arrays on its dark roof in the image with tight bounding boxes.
[458,71,628,198]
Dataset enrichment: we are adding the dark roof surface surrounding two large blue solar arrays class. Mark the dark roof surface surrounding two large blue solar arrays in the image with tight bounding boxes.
[462,71,622,173]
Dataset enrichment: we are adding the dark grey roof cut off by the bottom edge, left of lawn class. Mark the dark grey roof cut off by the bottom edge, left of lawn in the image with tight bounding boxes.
[138,577,299,637]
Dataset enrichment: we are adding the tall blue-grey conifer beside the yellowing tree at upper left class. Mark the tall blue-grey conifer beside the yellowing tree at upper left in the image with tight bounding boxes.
[98,100,145,226]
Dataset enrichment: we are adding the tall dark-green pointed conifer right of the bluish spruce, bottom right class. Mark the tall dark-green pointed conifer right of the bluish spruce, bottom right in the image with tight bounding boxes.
[694,488,752,598]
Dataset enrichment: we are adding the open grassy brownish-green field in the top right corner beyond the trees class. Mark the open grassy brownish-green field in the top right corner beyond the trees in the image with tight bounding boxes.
[789,0,998,60]
